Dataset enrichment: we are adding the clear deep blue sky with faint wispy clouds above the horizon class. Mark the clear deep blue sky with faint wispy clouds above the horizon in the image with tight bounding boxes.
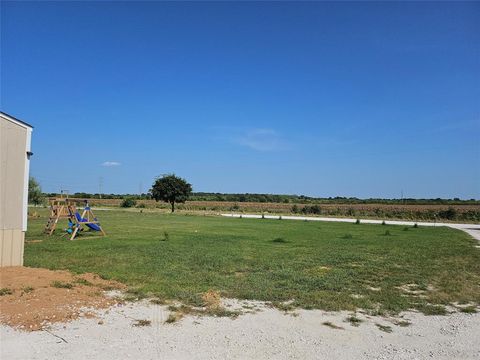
[0,1,480,199]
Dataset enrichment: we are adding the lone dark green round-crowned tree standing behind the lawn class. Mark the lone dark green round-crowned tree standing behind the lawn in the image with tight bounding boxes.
[150,174,192,213]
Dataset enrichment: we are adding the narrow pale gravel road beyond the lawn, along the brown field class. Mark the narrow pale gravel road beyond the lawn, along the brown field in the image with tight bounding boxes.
[221,214,480,241]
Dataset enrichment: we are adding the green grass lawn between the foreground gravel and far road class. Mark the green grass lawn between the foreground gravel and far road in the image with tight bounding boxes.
[25,211,480,314]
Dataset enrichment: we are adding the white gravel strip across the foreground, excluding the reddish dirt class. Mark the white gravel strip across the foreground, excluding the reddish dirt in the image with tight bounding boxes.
[0,302,480,360]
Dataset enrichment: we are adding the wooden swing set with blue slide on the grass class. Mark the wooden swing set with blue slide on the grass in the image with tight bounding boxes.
[45,198,106,240]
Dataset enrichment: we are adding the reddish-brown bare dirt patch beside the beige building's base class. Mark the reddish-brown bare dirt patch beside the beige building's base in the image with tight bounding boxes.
[0,267,125,331]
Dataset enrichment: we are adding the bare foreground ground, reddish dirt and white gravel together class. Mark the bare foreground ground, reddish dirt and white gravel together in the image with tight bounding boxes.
[0,267,480,360]
